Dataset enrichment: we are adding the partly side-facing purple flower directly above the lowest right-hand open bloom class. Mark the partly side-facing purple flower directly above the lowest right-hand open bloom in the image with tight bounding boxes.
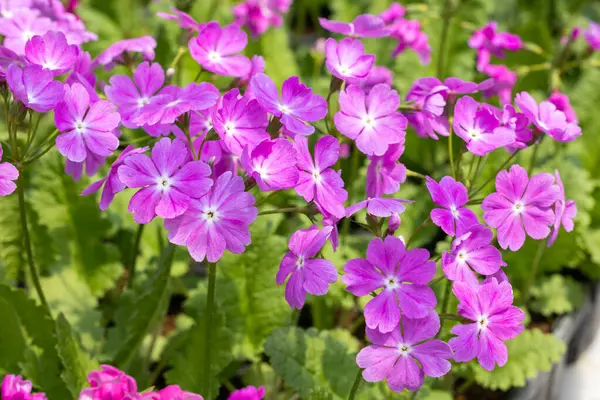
[442,225,506,286]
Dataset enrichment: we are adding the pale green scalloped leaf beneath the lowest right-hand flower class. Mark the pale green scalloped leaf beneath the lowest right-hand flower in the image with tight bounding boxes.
[471,329,566,390]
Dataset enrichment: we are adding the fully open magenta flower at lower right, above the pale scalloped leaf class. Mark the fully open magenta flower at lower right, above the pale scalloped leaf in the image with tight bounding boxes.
[448,278,525,371]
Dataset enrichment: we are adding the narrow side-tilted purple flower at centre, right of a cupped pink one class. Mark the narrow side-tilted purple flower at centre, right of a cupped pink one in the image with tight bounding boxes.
[294,135,348,218]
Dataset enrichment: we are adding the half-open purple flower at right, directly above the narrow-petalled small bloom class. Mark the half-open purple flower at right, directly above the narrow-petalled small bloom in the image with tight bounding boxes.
[453,96,515,156]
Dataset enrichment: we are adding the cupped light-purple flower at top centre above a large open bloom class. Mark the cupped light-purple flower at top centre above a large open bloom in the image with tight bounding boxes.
[325,38,375,80]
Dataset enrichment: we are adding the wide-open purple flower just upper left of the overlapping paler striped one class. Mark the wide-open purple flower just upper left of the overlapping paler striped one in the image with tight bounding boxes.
[118,138,212,224]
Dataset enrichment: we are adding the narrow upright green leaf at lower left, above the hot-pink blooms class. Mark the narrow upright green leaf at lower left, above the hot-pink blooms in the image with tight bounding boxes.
[56,314,99,399]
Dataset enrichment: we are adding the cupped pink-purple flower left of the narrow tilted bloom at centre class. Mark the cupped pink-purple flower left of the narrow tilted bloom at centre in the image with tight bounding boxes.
[241,139,299,191]
